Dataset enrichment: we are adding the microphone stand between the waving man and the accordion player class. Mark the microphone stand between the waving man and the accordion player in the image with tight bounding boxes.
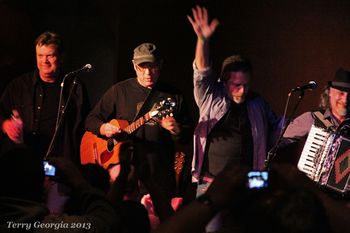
[264,90,304,170]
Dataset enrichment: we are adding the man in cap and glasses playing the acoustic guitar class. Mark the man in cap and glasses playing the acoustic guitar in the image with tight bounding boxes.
[85,43,191,200]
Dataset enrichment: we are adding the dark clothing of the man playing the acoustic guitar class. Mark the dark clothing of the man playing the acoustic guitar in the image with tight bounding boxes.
[85,78,193,197]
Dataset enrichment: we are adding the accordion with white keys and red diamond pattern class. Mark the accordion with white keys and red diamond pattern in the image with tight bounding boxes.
[298,125,350,194]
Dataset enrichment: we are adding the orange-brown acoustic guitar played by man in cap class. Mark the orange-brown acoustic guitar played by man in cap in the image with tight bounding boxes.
[80,98,176,169]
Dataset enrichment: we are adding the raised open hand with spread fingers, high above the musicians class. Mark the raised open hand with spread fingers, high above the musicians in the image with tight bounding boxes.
[187,5,219,40]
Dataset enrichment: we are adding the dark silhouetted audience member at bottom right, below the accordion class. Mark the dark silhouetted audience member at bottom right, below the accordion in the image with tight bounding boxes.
[217,164,331,233]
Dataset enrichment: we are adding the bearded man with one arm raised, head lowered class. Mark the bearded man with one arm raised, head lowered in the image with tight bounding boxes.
[188,6,282,232]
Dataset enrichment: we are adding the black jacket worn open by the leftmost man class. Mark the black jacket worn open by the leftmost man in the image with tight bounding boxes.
[0,70,89,163]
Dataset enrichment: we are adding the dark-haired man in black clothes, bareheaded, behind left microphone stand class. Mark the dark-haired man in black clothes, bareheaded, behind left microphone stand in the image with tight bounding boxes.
[0,32,89,164]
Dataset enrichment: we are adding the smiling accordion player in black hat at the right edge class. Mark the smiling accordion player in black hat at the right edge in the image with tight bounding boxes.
[283,68,350,143]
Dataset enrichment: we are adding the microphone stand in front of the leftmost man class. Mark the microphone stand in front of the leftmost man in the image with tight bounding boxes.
[44,72,78,160]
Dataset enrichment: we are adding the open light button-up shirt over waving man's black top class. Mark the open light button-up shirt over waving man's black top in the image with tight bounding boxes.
[192,63,282,182]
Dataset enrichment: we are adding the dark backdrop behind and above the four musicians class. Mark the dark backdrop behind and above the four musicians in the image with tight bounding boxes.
[0,0,350,160]
